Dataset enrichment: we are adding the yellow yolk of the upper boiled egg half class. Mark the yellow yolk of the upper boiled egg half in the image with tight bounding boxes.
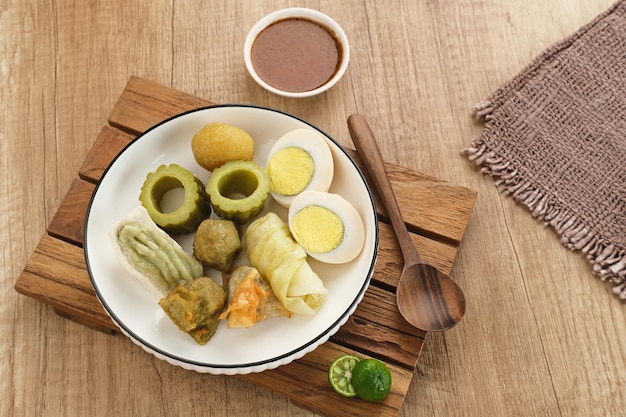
[267,146,315,195]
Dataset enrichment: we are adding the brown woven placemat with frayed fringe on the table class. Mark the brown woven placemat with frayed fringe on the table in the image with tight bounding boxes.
[464,0,626,299]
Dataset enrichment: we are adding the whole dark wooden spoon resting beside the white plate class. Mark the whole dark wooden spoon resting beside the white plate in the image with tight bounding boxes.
[348,114,465,331]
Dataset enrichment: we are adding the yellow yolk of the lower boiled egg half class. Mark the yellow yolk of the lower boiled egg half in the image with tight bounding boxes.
[291,205,344,253]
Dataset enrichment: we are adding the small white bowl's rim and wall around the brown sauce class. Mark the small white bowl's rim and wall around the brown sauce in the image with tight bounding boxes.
[243,7,350,98]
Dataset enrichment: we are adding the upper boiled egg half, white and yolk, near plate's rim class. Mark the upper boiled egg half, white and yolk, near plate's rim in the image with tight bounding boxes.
[267,129,334,207]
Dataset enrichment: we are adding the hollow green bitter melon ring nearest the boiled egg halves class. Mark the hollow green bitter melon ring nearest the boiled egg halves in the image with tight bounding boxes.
[206,161,270,223]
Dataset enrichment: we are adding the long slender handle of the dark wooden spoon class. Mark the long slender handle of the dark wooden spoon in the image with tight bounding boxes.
[348,114,422,265]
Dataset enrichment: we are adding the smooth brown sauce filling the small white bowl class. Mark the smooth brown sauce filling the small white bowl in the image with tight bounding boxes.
[251,18,343,93]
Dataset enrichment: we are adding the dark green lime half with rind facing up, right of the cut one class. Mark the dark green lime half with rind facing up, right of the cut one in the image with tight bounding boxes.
[351,359,391,402]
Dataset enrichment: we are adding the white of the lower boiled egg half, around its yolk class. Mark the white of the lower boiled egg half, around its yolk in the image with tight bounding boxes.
[288,190,365,264]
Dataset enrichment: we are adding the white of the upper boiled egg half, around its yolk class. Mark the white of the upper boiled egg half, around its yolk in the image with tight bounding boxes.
[267,129,335,207]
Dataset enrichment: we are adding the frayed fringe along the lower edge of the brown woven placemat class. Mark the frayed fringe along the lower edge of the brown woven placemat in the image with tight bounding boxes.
[463,134,626,300]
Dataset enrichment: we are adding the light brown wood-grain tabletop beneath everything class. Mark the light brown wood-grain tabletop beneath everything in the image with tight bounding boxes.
[0,0,626,417]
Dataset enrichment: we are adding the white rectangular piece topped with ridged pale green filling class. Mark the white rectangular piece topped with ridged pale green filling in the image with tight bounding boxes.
[110,206,203,297]
